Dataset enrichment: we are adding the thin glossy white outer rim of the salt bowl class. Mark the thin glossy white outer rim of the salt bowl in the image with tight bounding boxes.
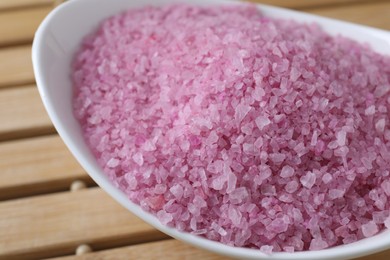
[32,0,390,260]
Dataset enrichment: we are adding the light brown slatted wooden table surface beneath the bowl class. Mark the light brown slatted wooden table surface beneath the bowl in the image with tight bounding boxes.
[0,0,390,260]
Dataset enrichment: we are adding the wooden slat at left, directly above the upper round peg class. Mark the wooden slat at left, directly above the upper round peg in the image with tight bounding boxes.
[0,135,93,200]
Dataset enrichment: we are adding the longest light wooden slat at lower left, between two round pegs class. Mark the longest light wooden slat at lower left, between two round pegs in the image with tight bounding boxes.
[0,188,166,260]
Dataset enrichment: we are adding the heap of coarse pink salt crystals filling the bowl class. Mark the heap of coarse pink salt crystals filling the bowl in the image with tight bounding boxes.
[72,4,390,254]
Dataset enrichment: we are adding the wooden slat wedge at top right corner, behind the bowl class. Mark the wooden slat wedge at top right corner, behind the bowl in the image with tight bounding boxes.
[310,1,390,30]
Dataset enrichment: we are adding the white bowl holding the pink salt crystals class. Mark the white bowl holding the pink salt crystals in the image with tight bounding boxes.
[32,0,390,260]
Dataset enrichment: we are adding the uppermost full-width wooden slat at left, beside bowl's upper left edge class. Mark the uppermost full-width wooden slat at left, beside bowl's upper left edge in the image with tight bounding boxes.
[0,6,52,46]
